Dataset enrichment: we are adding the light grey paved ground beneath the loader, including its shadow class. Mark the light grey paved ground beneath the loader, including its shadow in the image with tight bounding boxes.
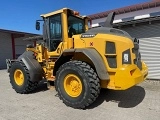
[0,70,160,120]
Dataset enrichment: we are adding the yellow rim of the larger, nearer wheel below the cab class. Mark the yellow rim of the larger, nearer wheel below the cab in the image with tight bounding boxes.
[64,74,82,97]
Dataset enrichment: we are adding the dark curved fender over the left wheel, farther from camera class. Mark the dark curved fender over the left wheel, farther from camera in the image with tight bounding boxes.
[17,51,43,82]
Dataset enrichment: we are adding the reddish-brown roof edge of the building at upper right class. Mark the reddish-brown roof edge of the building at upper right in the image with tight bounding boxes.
[88,0,160,20]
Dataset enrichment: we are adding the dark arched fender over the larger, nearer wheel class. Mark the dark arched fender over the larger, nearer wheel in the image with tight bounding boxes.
[53,48,109,80]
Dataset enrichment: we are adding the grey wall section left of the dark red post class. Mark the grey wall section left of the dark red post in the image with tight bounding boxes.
[0,32,13,69]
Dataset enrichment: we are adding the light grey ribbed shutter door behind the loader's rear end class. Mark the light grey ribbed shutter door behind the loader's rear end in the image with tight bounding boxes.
[140,37,160,79]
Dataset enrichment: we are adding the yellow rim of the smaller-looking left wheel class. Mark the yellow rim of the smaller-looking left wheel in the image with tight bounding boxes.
[14,69,24,86]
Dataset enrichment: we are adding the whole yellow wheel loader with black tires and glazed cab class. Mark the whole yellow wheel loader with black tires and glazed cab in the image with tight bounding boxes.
[6,8,148,109]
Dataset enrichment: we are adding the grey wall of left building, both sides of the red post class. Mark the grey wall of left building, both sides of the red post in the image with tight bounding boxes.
[0,32,34,69]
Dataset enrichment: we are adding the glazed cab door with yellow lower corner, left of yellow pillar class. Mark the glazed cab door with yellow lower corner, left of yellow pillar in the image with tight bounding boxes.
[47,14,64,57]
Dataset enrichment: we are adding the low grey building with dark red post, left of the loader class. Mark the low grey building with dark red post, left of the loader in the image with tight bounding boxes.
[0,29,36,69]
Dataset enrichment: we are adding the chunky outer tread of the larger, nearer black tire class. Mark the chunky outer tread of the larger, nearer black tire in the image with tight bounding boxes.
[55,60,100,109]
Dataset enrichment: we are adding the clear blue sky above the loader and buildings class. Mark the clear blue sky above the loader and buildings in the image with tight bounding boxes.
[0,0,151,33]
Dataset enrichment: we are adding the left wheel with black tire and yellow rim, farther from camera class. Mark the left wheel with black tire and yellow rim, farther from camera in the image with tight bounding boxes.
[9,62,38,94]
